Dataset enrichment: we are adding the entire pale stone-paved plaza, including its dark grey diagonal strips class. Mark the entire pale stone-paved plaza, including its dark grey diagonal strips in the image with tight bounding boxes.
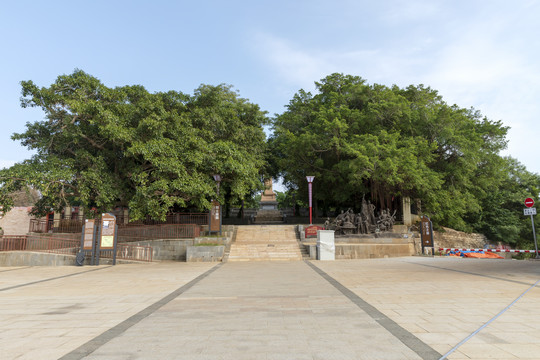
[0,257,540,360]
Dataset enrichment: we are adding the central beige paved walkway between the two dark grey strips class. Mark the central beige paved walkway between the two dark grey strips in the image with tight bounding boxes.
[79,262,419,359]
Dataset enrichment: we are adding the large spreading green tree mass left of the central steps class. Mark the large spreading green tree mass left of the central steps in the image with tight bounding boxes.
[0,70,267,219]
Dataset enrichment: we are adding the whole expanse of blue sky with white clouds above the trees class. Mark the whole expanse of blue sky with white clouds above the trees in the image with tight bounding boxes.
[0,0,540,179]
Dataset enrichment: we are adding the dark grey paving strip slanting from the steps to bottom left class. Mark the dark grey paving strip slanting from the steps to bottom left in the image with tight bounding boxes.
[59,263,223,360]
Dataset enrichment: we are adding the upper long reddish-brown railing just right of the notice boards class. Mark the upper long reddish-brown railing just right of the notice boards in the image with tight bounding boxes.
[118,224,201,243]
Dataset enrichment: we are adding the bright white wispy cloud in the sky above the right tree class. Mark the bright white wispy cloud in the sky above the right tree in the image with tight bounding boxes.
[255,1,540,173]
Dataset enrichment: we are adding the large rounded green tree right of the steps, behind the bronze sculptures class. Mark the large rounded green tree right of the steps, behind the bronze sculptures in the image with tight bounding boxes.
[269,74,507,230]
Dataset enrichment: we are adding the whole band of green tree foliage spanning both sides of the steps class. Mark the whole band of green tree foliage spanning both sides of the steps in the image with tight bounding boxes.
[0,70,540,248]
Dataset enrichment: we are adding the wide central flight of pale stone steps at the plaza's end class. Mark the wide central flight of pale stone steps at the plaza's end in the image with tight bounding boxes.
[227,225,307,261]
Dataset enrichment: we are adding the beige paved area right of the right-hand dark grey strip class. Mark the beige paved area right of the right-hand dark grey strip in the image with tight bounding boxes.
[317,257,540,359]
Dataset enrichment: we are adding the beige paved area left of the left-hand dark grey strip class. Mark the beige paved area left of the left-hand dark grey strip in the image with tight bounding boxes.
[0,263,215,359]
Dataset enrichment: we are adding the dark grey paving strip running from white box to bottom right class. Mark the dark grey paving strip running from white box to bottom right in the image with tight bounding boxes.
[305,260,441,360]
